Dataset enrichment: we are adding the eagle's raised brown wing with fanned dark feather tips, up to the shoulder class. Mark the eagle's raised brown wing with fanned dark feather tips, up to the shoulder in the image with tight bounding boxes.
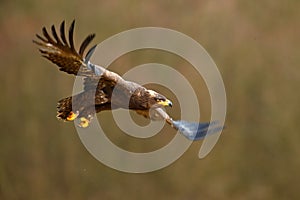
[33,20,122,86]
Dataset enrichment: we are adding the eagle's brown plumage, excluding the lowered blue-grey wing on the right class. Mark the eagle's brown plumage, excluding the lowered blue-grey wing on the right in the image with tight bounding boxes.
[33,21,171,125]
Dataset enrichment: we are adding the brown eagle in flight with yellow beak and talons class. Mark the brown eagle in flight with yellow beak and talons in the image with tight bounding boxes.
[33,20,222,141]
